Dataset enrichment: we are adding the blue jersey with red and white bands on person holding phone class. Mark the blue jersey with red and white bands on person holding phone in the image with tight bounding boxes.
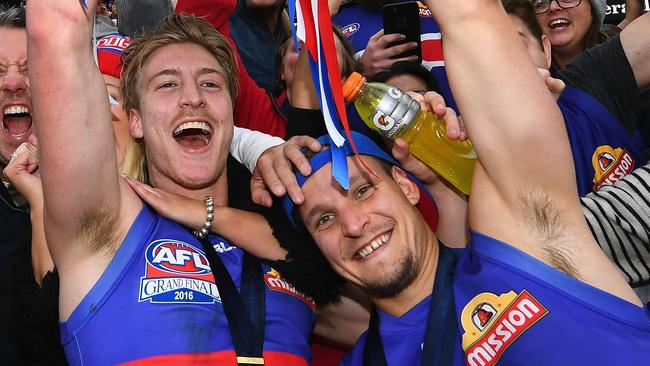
[332,1,458,111]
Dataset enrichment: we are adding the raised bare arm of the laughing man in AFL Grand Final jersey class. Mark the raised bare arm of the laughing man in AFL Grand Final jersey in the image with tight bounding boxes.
[27,0,140,271]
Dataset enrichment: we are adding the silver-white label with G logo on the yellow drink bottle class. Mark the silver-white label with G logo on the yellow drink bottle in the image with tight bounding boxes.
[370,87,420,138]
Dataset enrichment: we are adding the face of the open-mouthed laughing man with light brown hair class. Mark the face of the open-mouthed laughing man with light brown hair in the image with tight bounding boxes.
[129,43,233,189]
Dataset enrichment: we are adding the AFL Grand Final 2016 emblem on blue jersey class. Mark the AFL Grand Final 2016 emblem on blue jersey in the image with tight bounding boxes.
[139,239,221,304]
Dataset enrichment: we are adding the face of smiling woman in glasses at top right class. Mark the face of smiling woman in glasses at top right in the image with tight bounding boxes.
[537,0,592,49]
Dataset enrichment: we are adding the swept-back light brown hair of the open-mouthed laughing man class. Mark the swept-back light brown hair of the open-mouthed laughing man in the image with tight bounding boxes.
[120,14,238,113]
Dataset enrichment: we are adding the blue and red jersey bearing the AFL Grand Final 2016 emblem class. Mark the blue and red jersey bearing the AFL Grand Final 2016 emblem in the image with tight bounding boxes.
[61,205,315,365]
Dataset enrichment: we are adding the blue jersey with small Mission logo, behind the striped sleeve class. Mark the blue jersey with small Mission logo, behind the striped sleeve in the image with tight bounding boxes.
[557,86,643,196]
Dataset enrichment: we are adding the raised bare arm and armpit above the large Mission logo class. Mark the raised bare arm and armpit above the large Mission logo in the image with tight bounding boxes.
[427,0,640,303]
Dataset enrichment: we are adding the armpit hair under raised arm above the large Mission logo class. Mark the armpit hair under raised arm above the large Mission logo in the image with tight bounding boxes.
[518,186,580,279]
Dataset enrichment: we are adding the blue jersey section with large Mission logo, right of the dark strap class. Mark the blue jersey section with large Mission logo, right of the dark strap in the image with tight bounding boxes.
[454,232,650,366]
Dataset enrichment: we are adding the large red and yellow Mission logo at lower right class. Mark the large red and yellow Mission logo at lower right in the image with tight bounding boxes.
[461,290,548,366]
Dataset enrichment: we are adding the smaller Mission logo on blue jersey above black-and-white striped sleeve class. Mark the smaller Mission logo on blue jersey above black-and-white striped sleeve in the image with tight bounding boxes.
[591,145,634,191]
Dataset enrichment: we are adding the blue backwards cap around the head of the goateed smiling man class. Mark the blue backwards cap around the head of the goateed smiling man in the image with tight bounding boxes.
[282,131,437,227]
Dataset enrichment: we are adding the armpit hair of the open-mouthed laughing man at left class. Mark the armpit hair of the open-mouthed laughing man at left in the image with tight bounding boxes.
[77,207,118,254]
